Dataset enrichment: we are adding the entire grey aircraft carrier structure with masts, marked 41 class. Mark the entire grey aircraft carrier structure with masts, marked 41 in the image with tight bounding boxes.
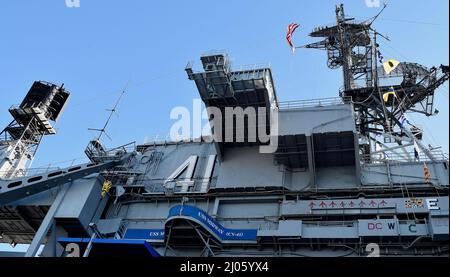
[0,5,449,257]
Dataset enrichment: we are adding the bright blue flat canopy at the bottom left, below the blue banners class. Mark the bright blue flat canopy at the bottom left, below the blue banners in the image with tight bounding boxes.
[58,235,160,257]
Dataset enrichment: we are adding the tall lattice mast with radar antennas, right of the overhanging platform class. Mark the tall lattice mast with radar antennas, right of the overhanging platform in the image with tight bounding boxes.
[300,4,449,160]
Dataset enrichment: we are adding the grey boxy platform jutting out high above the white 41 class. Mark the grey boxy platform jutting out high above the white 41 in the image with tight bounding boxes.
[186,53,278,156]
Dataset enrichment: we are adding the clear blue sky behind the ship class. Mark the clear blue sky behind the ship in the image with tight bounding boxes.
[0,0,449,250]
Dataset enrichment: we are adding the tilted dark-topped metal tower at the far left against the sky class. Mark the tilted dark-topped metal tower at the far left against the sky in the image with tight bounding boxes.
[0,81,70,179]
